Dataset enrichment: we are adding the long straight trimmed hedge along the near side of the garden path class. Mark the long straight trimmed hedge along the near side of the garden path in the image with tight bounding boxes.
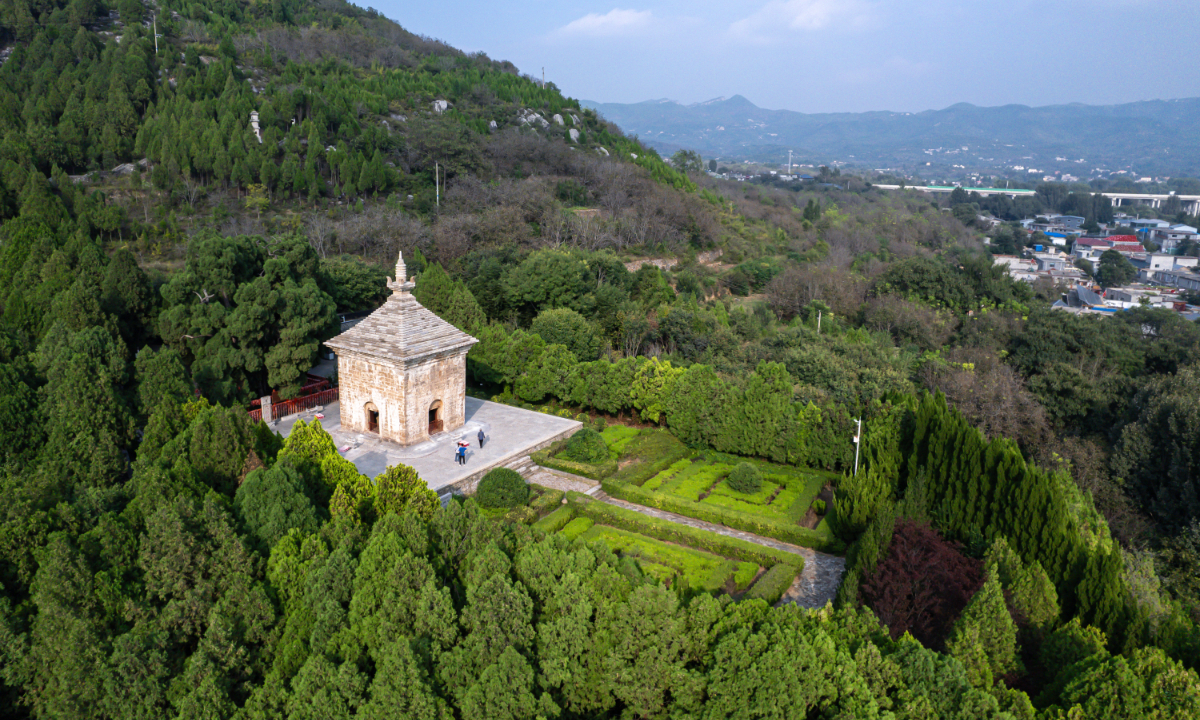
[566,492,804,568]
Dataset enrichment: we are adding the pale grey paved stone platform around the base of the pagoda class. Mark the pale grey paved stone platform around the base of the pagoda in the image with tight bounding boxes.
[271,397,583,497]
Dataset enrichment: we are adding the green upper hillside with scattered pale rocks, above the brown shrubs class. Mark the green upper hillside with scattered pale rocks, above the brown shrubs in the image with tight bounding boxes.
[0,0,685,234]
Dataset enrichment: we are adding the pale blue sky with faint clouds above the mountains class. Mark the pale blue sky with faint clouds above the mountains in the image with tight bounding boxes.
[360,0,1200,113]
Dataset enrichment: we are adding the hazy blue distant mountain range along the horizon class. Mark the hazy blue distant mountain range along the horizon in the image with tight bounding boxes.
[582,95,1200,179]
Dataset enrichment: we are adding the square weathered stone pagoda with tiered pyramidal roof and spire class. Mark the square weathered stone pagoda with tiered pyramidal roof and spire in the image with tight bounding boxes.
[325,253,479,445]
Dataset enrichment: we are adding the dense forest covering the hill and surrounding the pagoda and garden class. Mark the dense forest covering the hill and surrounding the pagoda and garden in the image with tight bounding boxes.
[0,0,1200,719]
